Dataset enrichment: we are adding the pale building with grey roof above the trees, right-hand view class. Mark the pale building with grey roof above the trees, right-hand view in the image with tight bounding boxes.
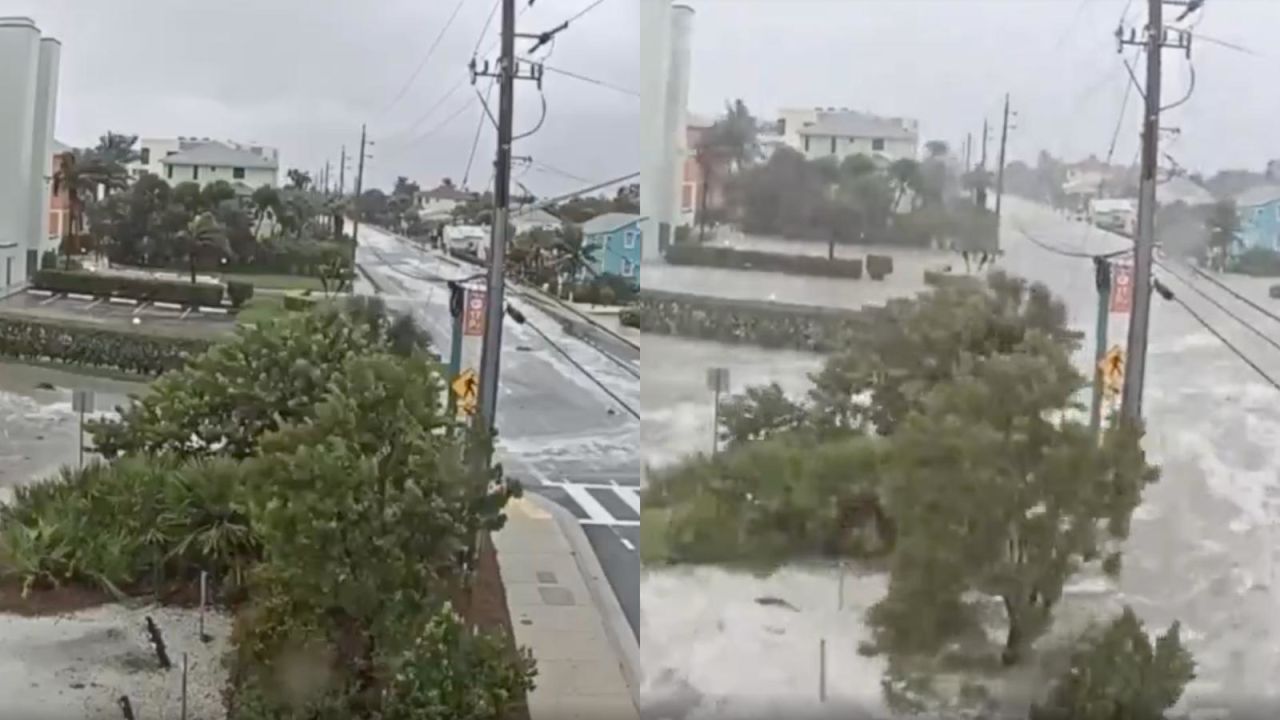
[780,108,920,161]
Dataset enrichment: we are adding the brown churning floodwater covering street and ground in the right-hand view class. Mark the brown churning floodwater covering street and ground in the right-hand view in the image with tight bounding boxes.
[641,199,1280,720]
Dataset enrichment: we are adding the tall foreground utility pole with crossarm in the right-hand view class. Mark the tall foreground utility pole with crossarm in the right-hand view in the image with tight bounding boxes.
[1116,0,1192,421]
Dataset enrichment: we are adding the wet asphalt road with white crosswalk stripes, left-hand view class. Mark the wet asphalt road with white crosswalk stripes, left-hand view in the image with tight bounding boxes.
[356,225,641,638]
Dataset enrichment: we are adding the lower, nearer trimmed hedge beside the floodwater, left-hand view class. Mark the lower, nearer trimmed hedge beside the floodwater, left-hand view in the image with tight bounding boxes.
[0,315,212,375]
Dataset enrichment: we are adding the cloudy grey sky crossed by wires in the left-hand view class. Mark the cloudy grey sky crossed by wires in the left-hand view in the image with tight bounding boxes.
[0,0,640,195]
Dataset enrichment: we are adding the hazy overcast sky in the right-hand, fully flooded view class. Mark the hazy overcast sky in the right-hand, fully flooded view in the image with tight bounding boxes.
[687,0,1280,170]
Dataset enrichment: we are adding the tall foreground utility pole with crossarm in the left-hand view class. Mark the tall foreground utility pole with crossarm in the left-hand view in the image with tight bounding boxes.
[471,0,547,432]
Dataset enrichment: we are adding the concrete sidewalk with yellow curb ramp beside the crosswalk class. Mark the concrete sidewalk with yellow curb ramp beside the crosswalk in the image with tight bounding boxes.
[493,492,640,720]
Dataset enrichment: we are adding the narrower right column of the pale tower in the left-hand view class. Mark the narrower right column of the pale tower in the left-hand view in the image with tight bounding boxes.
[27,37,63,262]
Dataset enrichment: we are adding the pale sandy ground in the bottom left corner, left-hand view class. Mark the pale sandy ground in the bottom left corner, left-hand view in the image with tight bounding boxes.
[0,605,230,720]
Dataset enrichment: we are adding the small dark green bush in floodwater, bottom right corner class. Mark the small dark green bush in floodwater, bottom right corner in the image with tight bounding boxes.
[1030,606,1196,720]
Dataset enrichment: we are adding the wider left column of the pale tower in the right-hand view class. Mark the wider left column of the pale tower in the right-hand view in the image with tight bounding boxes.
[640,0,671,263]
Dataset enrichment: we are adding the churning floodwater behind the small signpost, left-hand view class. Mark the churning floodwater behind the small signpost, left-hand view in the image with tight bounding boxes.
[0,363,146,489]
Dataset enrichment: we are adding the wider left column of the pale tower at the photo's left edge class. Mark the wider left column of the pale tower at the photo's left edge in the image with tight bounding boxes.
[0,17,40,288]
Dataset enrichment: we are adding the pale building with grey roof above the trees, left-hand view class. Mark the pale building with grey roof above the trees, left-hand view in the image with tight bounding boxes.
[129,137,280,188]
